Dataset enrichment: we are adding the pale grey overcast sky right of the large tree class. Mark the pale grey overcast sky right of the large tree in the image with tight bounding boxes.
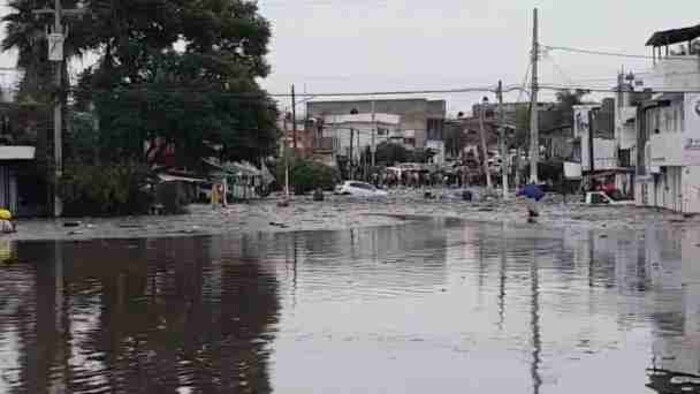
[259,0,700,113]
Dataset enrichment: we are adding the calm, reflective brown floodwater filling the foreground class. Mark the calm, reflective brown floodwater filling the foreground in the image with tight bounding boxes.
[0,219,700,393]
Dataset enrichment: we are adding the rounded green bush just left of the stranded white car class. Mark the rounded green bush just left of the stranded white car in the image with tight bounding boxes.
[275,159,338,194]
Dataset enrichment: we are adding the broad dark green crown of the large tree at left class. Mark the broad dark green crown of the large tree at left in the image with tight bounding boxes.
[82,0,276,166]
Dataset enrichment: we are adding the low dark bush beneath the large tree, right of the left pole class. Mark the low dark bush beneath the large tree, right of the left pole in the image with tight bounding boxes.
[59,165,152,216]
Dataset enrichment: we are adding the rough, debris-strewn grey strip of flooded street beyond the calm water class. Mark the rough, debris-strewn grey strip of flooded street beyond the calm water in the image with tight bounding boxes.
[3,189,700,240]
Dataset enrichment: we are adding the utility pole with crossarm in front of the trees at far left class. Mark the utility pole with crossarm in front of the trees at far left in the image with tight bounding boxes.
[32,0,84,217]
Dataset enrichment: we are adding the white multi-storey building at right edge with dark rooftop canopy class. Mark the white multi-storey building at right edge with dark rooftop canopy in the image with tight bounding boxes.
[635,26,700,213]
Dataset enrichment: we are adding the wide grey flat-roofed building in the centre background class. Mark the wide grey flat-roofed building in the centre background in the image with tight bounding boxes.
[306,98,446,162]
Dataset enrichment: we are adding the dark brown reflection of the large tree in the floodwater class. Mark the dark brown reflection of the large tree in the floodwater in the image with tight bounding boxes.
[0,238,279,393]
